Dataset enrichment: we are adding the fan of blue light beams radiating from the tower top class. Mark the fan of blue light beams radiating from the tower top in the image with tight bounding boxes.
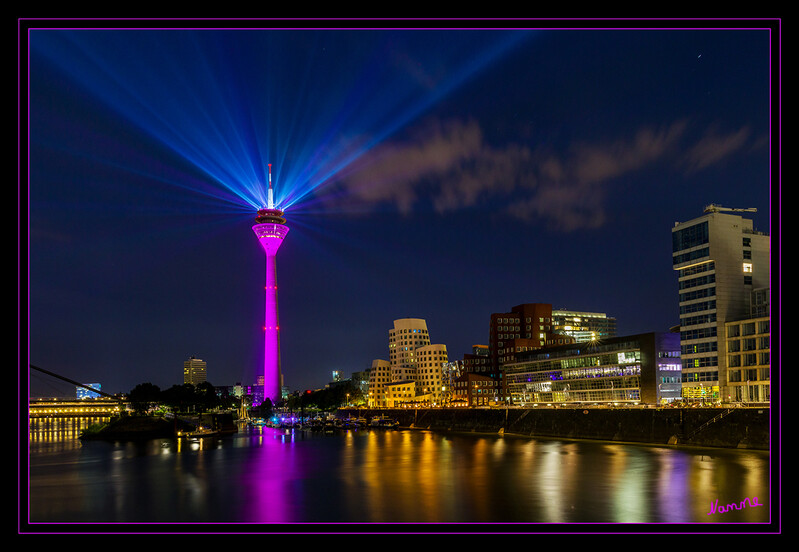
[30,30,530,216]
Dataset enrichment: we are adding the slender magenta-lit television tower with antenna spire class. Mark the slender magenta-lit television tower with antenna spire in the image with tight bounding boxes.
[252,165,289,404]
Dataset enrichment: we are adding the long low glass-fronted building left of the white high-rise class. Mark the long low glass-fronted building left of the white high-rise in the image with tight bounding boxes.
[505,332,682,406]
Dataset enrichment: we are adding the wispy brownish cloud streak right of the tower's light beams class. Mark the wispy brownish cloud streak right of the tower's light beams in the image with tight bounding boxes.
[324,121,749,231]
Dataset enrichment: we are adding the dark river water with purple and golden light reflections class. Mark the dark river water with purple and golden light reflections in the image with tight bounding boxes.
[25,421,776,532]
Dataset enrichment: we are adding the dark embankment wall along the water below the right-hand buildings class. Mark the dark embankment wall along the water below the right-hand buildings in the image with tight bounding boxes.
[338,408,771,450]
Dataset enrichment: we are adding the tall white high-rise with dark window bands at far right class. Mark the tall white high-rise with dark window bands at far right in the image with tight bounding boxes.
[671,205,771,403]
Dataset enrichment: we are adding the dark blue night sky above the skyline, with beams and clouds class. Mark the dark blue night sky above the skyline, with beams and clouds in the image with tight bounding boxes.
[20,21,777,395]
